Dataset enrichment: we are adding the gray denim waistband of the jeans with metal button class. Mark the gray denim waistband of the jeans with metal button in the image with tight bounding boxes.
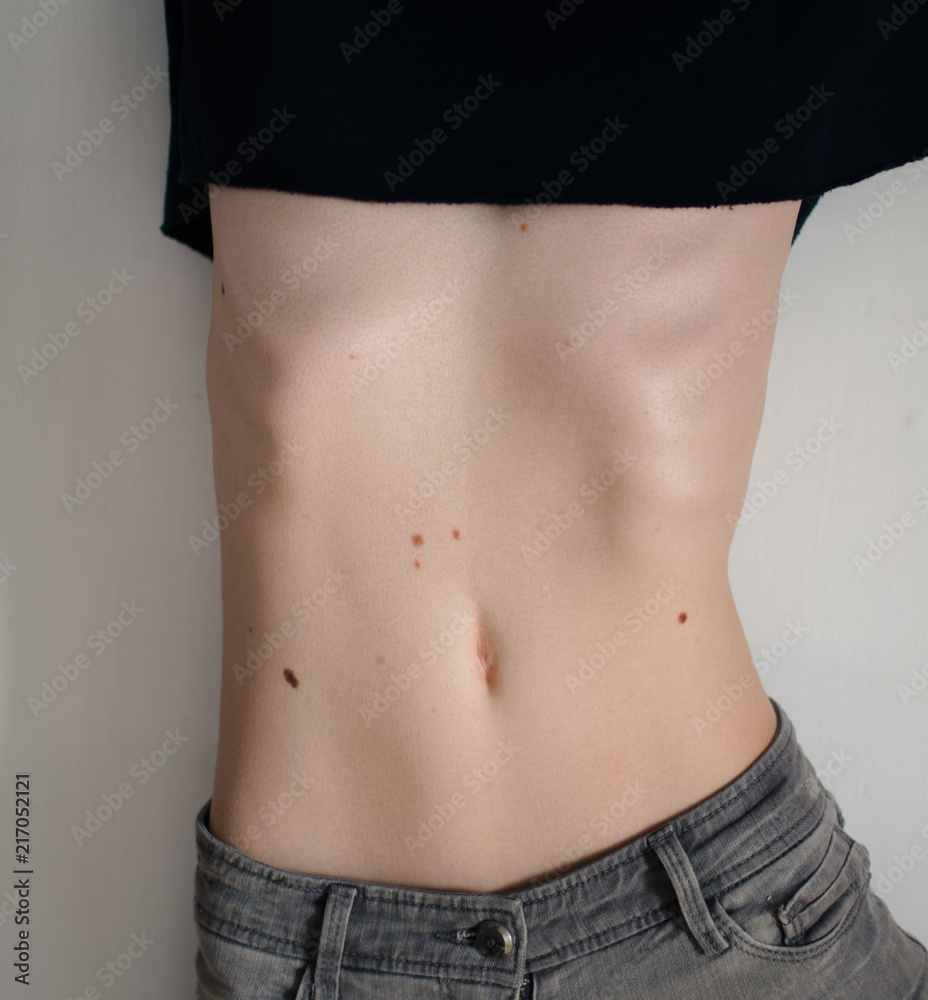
[195,698,843,988]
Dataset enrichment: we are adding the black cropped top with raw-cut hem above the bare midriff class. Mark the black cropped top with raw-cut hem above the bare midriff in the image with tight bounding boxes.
[161,0,928,257]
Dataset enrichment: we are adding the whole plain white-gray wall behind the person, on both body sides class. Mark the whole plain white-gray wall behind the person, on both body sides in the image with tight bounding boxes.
[0,0,928,1000]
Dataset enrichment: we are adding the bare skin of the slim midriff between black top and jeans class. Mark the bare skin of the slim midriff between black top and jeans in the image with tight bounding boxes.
[207,188,799,892]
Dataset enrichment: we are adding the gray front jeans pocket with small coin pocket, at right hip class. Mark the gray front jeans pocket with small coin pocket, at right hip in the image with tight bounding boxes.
[713,823,870,959]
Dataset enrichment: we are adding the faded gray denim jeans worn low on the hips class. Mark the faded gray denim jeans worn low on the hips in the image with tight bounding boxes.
[195,699,928,1000]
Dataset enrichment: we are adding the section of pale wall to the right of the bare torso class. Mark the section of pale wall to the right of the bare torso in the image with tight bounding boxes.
[730,174,928,943]
